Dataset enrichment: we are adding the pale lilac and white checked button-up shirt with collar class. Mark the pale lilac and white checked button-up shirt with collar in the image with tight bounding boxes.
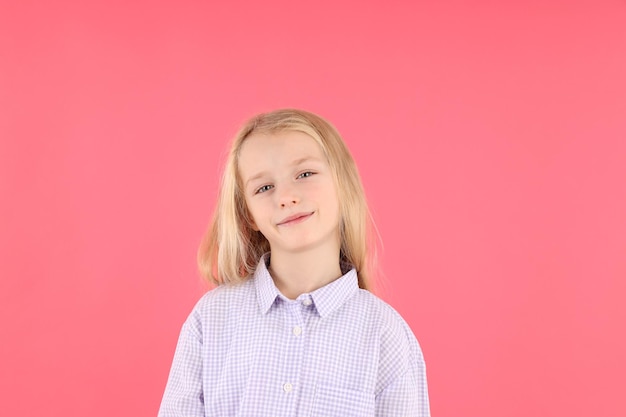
[159,257,430,417]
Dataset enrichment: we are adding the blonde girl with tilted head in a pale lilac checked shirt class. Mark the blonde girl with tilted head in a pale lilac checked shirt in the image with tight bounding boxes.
[159,109,430,417]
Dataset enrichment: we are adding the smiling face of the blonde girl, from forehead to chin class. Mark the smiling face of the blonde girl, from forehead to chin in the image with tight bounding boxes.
[239,131,340,253]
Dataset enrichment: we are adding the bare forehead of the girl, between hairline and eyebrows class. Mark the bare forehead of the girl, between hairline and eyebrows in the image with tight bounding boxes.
[237,130,326,176]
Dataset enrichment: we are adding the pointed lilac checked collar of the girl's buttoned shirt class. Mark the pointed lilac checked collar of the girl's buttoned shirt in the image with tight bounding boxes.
[253,254,359,318]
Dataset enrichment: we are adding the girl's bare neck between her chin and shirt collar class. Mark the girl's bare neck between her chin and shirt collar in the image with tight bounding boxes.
[269,247,341,299]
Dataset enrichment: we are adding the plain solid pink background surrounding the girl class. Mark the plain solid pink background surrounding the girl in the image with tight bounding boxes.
[0,0,626,417]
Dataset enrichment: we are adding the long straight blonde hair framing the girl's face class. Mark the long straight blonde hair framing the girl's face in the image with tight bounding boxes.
[198,109,374,290]
